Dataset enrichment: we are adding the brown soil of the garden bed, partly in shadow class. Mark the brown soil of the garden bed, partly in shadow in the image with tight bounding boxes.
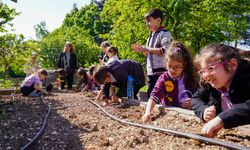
[0,91,250,150]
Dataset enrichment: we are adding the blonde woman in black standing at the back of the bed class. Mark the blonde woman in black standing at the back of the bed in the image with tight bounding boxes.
[57,42,77,89]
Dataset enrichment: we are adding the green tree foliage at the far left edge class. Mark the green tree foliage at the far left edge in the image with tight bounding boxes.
[0,1,33,79]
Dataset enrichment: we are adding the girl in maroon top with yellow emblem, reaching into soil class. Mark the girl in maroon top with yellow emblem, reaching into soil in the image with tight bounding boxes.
[142,42,198,121]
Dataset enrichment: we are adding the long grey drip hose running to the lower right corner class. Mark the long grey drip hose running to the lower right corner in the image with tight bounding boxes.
[83,96,250,150]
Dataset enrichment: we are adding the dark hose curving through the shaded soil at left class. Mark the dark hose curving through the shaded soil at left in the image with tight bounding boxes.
[21,96,51,150]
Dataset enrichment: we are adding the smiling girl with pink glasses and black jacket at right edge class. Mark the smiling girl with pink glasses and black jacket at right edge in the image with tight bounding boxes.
[192,44,250,137]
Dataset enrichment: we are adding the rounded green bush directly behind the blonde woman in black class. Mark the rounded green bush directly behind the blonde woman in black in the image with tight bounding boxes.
[39,27,99,69]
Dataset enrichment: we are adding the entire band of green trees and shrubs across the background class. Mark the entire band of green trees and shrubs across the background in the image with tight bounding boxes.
[3,0,250,78]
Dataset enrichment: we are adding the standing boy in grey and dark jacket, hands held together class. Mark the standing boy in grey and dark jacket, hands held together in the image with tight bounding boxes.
[132,9,173,96]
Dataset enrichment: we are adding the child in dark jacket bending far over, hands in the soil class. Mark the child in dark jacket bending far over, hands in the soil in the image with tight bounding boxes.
[94,60,145,105]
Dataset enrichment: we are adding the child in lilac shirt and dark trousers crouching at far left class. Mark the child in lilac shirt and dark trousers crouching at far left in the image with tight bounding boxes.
[20,69,48,97]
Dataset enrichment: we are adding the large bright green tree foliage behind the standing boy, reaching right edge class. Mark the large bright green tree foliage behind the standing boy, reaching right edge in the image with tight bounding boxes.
[101,0,250,54]
